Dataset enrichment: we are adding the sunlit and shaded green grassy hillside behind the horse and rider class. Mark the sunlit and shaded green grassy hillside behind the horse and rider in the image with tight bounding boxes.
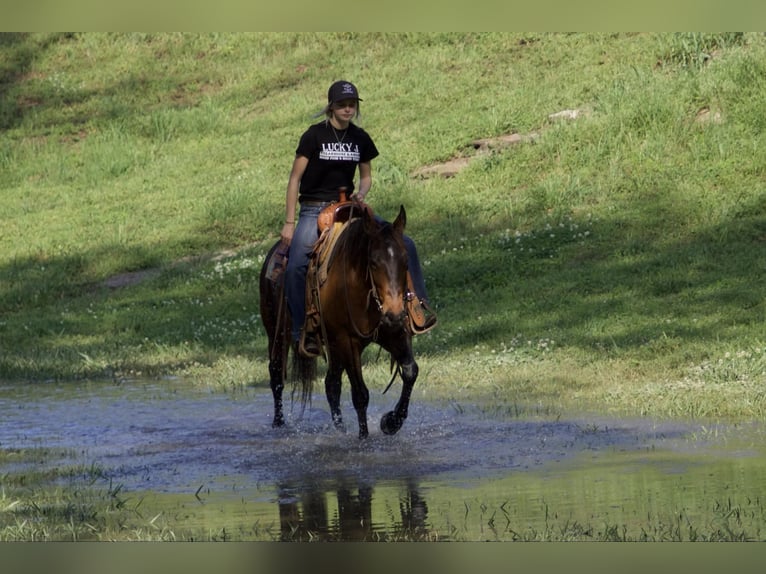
[0,33,766,424]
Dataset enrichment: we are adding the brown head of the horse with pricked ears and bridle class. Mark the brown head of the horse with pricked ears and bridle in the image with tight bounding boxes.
[365,206,407,328]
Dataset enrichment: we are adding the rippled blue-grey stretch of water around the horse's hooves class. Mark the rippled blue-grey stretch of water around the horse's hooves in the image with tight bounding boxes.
[0,381,756,491]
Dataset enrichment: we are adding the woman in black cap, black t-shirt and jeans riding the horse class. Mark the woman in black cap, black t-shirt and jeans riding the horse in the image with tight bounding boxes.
[281,80,436,356]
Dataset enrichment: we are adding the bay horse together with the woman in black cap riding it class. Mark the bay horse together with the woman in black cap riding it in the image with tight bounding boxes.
[261,81,436,437]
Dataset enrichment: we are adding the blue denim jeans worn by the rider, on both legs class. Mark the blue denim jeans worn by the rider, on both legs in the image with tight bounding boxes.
[285,204,428,341]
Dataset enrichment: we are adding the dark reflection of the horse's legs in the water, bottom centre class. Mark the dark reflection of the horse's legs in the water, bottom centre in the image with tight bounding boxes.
[277,481,431,542]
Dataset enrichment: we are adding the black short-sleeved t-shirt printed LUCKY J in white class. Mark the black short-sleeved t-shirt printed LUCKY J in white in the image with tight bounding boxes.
[295,121,378,201]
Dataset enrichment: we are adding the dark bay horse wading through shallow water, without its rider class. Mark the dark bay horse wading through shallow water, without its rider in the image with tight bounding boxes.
[260,206,418,438]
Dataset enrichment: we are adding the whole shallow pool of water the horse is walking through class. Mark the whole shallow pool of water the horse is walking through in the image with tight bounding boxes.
[0,380,766,540]
